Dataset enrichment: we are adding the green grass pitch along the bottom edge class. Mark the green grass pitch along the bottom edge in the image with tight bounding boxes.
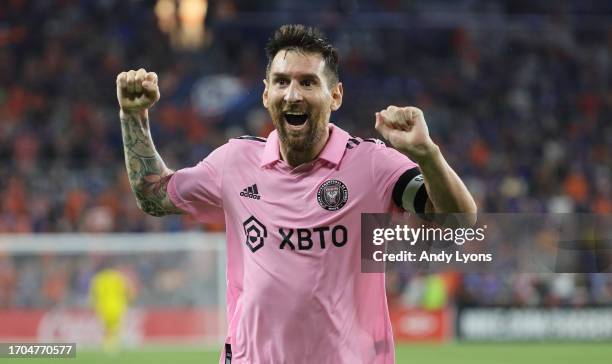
[8,343,612,364]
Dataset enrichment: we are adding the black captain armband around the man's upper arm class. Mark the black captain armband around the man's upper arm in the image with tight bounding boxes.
[393,167,427,214]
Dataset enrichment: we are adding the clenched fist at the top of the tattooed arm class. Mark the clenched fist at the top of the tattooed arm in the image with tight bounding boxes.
[117,68,159,111]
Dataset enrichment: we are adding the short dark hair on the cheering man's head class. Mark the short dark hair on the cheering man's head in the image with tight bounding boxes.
[266,24,339,85]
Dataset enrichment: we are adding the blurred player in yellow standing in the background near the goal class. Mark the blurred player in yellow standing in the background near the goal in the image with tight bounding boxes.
[90,265,133,354]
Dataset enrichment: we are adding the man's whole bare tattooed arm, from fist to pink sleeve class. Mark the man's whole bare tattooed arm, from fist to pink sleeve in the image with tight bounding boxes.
[117,68,182,216]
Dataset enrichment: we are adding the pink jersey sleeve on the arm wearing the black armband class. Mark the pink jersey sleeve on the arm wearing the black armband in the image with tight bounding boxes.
[372,141,421,211]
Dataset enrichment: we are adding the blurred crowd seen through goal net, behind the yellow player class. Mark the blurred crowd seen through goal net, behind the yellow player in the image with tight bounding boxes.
[0,251,220,309]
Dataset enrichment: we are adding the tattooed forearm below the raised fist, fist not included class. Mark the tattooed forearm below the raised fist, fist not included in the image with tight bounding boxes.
[120,110,181,216]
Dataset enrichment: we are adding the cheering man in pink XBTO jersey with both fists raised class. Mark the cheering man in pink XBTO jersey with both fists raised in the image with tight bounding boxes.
[117,25,476,364]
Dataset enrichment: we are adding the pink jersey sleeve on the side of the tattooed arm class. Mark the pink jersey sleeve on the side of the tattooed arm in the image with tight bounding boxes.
[168,144,229,222]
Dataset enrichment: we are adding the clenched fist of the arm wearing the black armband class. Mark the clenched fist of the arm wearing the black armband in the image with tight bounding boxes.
[375,106,437,163]
